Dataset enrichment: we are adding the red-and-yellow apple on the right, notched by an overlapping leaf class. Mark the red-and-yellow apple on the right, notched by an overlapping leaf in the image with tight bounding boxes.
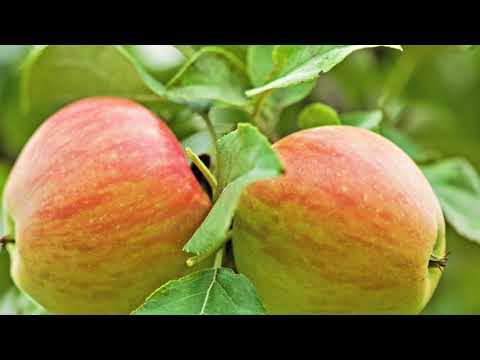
[233,126,445,314]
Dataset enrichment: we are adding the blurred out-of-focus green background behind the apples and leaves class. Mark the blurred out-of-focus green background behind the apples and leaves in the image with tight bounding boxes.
[0,45,480,314]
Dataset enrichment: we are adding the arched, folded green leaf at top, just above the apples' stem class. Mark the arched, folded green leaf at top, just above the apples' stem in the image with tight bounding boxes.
[167,46,249,109]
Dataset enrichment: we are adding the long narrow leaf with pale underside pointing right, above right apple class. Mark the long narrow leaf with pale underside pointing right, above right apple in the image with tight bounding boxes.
[246,45,401,97]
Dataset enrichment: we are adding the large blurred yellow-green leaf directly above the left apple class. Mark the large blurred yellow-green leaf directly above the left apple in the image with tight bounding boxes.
[22,45,165,114]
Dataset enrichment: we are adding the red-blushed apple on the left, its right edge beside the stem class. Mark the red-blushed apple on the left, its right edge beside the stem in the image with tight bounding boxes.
[4,97,211,314]
